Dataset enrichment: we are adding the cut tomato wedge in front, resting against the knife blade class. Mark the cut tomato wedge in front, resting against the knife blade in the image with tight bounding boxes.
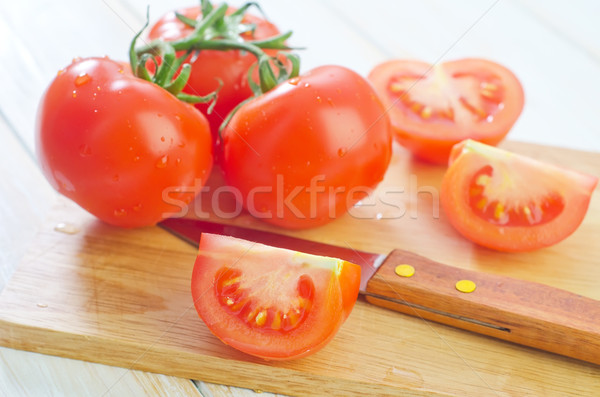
[192,233,360,360]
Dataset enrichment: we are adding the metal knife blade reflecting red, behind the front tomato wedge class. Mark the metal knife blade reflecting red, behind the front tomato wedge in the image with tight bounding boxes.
[158,218,386,293]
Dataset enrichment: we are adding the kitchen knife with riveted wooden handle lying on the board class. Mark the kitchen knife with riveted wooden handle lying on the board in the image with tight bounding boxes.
[159,218,600,365]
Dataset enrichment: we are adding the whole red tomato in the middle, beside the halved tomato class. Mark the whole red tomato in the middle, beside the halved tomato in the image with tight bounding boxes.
[222,66,392,229]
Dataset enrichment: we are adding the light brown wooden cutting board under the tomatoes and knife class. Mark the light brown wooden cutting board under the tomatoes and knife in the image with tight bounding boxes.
[0,142,600,396]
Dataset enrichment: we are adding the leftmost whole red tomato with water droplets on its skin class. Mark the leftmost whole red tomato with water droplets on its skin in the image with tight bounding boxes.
[36,58,212,227]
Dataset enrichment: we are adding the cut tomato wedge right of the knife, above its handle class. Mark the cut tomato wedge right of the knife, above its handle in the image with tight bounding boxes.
[441,140,598,252]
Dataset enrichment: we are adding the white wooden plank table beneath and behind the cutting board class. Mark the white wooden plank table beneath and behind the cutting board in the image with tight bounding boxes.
[0,0,600,396]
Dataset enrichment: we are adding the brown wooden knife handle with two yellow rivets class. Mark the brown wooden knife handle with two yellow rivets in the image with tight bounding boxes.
[365,250,600,365]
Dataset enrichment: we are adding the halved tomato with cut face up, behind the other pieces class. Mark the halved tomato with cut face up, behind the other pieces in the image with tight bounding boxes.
[369,59,524,164]
